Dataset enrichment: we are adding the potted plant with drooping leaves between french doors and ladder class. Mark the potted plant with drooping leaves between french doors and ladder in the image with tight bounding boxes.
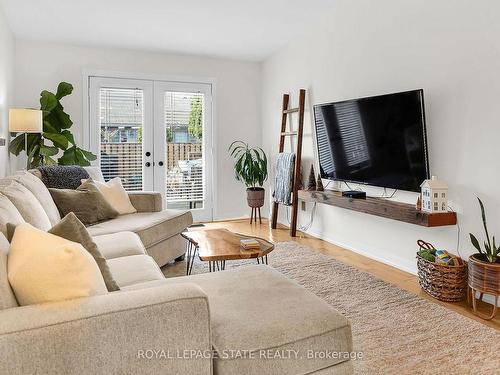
[229,141,267,214]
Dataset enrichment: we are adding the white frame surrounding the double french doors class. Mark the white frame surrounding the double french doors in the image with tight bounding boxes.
[82,69,219,218]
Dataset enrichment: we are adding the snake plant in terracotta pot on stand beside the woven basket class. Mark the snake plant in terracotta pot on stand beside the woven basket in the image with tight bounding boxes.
[469,198,500,320]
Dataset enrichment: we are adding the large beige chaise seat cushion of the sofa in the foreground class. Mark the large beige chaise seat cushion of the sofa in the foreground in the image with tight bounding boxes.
[143,265,352,374]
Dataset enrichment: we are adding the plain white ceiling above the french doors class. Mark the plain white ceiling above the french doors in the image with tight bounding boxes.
[0,0,334,61]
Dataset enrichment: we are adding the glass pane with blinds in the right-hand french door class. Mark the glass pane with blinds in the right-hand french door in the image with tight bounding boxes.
[164,92,205,209]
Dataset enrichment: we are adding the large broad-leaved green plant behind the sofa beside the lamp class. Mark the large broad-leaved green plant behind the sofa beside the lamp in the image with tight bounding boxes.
[9,82,96,168]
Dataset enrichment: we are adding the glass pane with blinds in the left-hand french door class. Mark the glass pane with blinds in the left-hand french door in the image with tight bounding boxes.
[99,88,144,190]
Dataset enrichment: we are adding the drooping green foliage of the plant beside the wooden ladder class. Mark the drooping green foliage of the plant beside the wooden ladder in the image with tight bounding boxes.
[229,141,267,189]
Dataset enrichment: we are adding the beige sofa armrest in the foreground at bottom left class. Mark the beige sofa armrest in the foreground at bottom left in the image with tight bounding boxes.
[0,283,212,374]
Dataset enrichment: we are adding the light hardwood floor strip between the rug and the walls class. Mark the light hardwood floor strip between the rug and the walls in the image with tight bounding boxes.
[200,219,500,330]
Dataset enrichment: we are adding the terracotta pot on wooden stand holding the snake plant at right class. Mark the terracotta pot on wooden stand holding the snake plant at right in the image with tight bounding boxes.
[468,254,500,320]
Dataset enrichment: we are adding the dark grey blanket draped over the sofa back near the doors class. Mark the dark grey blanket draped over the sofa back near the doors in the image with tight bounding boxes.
[38,165,90,189]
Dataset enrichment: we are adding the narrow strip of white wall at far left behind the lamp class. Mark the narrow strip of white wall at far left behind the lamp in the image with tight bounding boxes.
[0,8,14,177]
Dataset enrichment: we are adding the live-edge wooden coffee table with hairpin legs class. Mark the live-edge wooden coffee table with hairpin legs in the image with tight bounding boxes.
[182,229,274,275]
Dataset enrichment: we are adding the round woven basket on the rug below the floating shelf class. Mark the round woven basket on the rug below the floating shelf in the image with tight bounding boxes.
[417,254,467,302]
